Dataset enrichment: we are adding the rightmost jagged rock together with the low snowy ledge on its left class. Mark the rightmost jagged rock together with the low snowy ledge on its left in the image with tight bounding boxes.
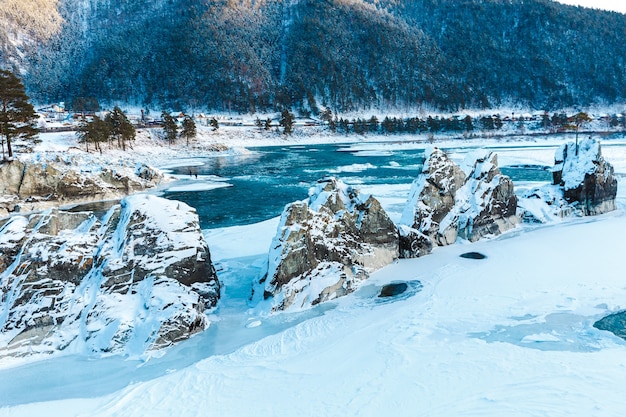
[519,138,617,223]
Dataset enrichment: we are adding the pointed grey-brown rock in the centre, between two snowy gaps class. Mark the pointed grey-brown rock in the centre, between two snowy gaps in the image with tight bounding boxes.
[264,178,398,310]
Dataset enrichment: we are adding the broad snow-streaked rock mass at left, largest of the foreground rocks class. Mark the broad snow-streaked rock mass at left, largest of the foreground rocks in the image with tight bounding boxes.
[0,195,220,356]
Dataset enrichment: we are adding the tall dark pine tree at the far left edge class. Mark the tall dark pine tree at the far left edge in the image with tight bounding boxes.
[0,70,39,159]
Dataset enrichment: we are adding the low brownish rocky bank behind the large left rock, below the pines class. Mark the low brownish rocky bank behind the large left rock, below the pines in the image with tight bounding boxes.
[0,157,163,216]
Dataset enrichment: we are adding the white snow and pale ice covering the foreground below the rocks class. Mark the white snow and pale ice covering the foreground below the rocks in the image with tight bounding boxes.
[0,132,626,417]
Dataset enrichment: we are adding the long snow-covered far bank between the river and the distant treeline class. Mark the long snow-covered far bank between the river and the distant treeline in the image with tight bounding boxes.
[31,126,626,169]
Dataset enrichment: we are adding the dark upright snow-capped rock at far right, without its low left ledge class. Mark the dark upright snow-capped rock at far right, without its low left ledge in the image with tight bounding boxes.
[552,138,617,216]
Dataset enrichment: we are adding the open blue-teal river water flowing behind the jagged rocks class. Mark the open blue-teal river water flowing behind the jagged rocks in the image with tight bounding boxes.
[164,145,551,229]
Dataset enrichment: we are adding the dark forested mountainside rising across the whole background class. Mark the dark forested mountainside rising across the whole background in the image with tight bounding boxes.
[0,0,626,113]
